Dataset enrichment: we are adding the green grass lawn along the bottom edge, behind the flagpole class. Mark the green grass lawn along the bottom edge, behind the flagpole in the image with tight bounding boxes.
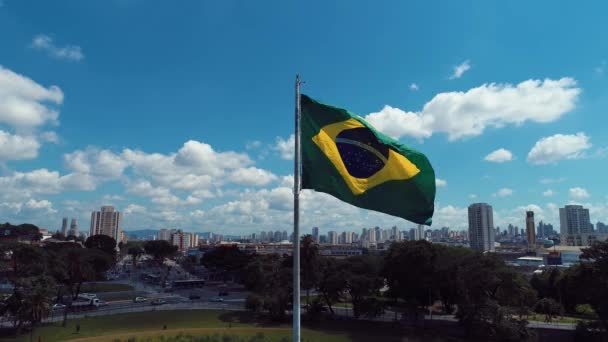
[0,310,458,342]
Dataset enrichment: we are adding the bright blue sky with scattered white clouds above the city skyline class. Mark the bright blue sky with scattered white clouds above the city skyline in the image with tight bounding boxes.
[0,0,608,233]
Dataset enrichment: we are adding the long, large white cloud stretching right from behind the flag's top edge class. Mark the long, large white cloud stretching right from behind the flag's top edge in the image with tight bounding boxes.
[366,78,581,141]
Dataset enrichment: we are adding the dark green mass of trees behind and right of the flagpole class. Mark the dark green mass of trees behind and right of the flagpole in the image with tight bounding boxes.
[202,236,608,341]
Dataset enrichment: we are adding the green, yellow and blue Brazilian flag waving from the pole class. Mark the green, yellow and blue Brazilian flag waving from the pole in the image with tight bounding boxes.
[300,95,435,225]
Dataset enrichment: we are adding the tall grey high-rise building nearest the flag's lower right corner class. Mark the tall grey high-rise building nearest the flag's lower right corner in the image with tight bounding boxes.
[469,203,495,252]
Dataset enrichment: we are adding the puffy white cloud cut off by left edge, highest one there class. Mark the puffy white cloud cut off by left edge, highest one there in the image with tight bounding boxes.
[0,66,63,130]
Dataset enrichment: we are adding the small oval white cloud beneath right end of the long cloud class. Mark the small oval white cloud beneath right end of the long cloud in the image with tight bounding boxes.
[528,132,591,165]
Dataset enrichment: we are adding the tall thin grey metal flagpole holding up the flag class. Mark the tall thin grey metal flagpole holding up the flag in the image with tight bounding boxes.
[292,75,302,342]
